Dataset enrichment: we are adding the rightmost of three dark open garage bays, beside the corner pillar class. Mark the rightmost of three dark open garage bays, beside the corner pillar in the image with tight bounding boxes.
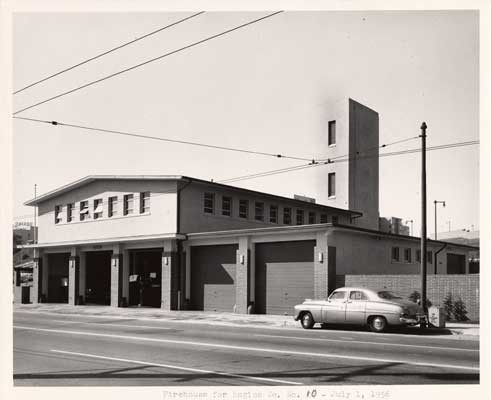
[128,248,162,307]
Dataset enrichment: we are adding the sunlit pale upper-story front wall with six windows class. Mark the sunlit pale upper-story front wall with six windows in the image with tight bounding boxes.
[38,180,177,243]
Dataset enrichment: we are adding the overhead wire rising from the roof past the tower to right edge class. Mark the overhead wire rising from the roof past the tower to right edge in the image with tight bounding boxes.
[217,140,480,183]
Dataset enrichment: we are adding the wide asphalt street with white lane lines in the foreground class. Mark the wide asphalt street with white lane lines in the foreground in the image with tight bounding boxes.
[14,311,479,386]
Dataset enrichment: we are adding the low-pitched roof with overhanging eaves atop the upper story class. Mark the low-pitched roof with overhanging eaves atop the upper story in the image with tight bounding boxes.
[24,175,362,216]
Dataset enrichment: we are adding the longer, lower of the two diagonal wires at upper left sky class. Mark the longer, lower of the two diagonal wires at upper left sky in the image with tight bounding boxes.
[14,11,283,115]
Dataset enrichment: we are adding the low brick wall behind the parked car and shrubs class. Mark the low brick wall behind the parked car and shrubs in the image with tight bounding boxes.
[337,274,480,321]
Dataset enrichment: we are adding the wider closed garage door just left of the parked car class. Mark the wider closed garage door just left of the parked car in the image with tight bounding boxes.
[255,240,316,314]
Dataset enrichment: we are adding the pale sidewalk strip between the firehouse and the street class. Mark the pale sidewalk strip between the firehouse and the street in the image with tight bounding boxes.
[13,304,480,340]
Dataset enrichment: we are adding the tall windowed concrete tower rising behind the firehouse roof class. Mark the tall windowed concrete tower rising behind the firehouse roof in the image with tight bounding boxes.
[323,98,379,230]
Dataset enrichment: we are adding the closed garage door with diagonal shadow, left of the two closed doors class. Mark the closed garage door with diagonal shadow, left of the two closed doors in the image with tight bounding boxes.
[190,245,238,312]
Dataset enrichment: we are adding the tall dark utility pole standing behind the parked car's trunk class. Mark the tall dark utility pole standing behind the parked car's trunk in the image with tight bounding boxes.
[420,122,427,328]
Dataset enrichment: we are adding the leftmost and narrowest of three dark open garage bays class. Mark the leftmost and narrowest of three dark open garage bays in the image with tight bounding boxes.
[48,253,70,303]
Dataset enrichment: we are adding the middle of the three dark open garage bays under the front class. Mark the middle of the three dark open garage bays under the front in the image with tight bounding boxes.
[85,251,113,305]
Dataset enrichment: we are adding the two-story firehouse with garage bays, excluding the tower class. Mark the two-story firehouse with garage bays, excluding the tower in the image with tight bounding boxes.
[19,175,476,313]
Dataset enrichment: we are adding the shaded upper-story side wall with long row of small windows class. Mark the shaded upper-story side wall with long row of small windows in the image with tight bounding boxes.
[180,182,349,233]
